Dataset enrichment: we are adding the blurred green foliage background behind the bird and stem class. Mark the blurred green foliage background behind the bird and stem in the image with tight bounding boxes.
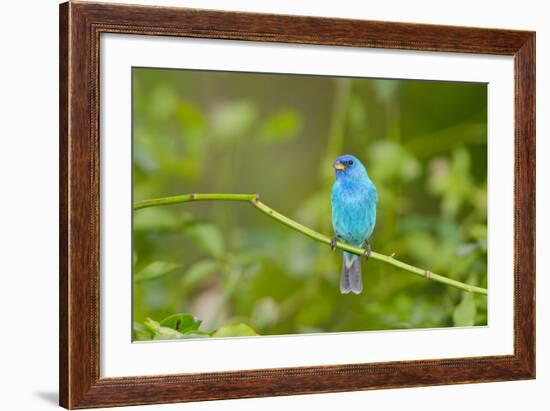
[133,68,487,340]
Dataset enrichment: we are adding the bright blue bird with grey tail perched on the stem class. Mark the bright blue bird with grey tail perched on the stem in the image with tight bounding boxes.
[331,154,378,294]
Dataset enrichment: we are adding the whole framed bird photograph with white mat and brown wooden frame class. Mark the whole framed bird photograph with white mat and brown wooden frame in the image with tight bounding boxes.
[60,2,535,408]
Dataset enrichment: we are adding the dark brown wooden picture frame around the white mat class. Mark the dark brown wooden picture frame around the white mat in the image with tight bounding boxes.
[59,3,535,408]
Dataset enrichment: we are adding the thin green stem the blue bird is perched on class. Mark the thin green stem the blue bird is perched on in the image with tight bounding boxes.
[134,194,487,295]
